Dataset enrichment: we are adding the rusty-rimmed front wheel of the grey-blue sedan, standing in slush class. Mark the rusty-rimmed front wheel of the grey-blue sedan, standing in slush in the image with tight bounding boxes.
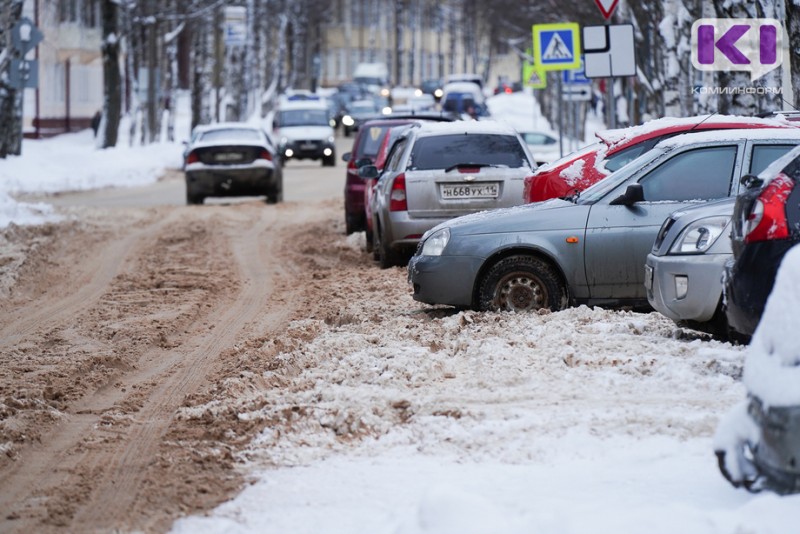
[478,256,567,312]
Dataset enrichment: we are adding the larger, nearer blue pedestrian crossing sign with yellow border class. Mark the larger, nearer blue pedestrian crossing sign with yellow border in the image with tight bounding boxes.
[532,22,581,70]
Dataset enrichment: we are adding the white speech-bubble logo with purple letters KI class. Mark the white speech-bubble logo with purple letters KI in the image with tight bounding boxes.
[692,19,784,81]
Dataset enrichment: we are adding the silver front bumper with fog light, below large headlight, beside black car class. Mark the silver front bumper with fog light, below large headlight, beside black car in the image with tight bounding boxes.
[645,254,731,323]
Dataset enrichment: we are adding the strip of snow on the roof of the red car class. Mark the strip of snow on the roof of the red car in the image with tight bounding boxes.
[595,115,797,149]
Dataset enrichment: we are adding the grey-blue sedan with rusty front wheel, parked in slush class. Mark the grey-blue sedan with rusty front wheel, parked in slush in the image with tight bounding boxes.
[408,128,800,311]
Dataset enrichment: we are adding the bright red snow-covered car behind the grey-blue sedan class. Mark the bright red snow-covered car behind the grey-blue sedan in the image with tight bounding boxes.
[523,115,797,202]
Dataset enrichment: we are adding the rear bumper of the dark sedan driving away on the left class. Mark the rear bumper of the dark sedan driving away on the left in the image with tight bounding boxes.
[186,167,278,196]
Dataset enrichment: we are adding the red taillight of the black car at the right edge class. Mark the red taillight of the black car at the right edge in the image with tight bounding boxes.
[744,173,794,243]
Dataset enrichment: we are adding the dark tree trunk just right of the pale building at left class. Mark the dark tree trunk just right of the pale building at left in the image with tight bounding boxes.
[97,0,122,148]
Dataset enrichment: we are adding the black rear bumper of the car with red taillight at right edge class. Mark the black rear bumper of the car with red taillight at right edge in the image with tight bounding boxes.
[724,240,794,336]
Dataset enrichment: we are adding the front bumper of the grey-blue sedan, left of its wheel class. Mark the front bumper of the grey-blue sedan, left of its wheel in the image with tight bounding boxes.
[408,256,484,307]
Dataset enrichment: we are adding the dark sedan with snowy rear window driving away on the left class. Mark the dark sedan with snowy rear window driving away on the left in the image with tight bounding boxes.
[184,123,283,204]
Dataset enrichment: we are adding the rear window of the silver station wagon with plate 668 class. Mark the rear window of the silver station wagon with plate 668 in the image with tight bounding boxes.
[409,134,530,171]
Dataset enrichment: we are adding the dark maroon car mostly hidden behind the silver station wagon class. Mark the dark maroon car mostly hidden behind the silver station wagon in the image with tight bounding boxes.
[342,114,452,235]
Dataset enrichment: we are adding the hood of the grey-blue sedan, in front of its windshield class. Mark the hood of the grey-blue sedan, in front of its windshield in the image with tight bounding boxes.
[431,199,589,235]
